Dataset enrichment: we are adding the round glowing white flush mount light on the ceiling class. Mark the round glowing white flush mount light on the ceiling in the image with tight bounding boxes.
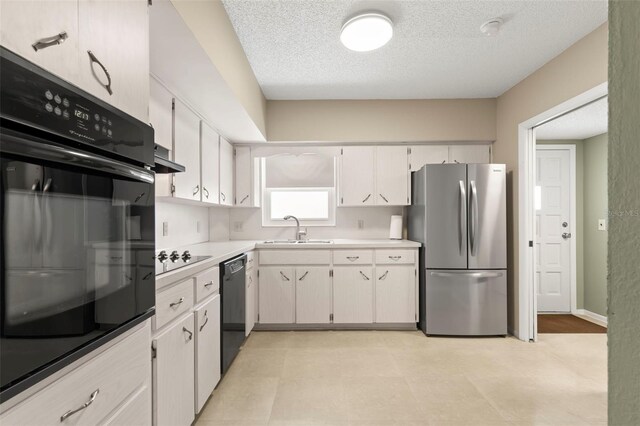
[340,12,393,52]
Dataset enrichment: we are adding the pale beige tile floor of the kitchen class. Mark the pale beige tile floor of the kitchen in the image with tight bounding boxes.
[196,331,607,426]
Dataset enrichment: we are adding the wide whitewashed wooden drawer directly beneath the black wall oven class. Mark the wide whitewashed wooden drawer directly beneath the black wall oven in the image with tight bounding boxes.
[0,323,151,425]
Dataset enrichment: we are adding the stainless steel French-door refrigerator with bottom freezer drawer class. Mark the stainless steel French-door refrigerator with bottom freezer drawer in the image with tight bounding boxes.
[408,164,507,336]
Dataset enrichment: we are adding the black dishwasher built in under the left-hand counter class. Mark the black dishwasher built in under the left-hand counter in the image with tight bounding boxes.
[220,254,247,374]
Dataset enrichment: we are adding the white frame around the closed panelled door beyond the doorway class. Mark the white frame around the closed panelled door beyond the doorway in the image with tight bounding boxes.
[533,146,578,316]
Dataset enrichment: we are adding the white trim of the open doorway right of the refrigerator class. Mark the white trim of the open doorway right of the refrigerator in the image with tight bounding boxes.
[514,82,608,341]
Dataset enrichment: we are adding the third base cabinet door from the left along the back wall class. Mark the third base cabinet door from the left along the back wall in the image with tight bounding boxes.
[333,266,374,324]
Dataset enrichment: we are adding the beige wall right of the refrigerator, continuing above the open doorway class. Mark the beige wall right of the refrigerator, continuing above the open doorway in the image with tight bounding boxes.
[493,24,608,332]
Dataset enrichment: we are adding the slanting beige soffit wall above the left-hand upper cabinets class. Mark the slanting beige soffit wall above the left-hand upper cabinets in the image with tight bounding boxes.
[171,0,267,138]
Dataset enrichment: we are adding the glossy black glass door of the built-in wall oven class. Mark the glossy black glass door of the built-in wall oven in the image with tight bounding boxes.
[0,129,155,399]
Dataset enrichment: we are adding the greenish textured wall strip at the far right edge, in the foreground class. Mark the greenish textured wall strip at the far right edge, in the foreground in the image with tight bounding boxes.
[608,1,640,426]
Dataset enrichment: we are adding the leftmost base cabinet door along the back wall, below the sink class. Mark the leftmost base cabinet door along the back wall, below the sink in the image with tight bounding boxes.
[258,266,295,324]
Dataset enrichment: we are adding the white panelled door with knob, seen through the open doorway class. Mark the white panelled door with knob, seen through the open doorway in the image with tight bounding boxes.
[535,147,575,312]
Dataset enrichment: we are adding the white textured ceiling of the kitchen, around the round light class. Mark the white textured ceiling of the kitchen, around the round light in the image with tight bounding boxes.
[223,0,607,99]
